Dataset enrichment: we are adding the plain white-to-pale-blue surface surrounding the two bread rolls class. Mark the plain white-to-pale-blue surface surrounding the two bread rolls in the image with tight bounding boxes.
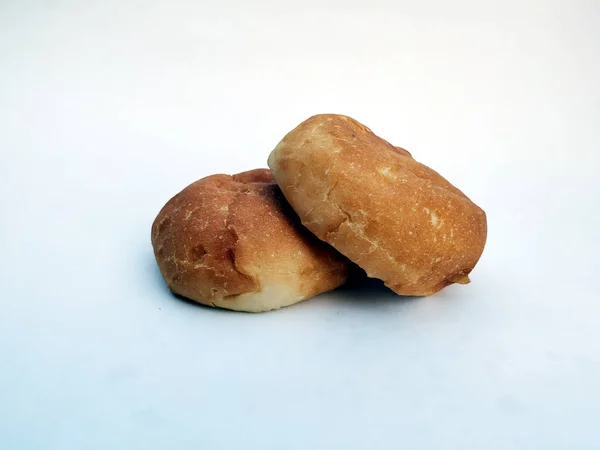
[0,0,600,450]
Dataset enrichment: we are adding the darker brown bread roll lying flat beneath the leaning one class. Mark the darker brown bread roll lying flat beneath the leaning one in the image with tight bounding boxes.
[152,169,348,312]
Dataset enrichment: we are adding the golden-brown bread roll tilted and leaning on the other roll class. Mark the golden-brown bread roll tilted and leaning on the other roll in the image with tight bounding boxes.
[269,114,487,295]
